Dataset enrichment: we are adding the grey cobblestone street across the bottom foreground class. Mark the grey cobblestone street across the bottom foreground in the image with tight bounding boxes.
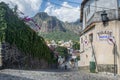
[0,69,120,80]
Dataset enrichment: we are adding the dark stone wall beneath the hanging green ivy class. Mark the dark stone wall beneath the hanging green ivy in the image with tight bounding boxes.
[1,43,50,69]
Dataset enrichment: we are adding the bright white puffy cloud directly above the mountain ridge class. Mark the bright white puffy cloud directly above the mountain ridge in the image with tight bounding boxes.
[45,2,80,22]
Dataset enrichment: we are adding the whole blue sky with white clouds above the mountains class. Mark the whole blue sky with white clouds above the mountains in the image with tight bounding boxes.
[0,0,82,22]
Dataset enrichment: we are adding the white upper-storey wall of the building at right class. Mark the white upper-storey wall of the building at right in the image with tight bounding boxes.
[83,0,120,29]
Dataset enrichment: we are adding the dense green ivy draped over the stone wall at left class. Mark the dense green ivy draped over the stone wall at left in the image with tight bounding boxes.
[0,2,52,62]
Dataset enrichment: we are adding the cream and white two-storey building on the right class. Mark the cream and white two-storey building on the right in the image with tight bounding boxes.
[79,0,120,73]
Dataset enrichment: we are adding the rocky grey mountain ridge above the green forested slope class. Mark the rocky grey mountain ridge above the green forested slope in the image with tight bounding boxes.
[32,12,80,33]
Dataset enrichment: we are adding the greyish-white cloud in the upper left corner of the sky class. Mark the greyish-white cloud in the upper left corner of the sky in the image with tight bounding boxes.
[0,0,42,16]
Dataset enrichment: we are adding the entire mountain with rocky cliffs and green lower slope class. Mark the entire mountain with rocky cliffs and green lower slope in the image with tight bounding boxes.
[33,12,81,41]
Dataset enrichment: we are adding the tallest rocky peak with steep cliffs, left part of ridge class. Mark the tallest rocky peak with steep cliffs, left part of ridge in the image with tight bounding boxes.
[33,12,66,33]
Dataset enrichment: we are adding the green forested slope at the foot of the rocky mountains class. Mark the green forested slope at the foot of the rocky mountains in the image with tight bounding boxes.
[39,31,79,41]
